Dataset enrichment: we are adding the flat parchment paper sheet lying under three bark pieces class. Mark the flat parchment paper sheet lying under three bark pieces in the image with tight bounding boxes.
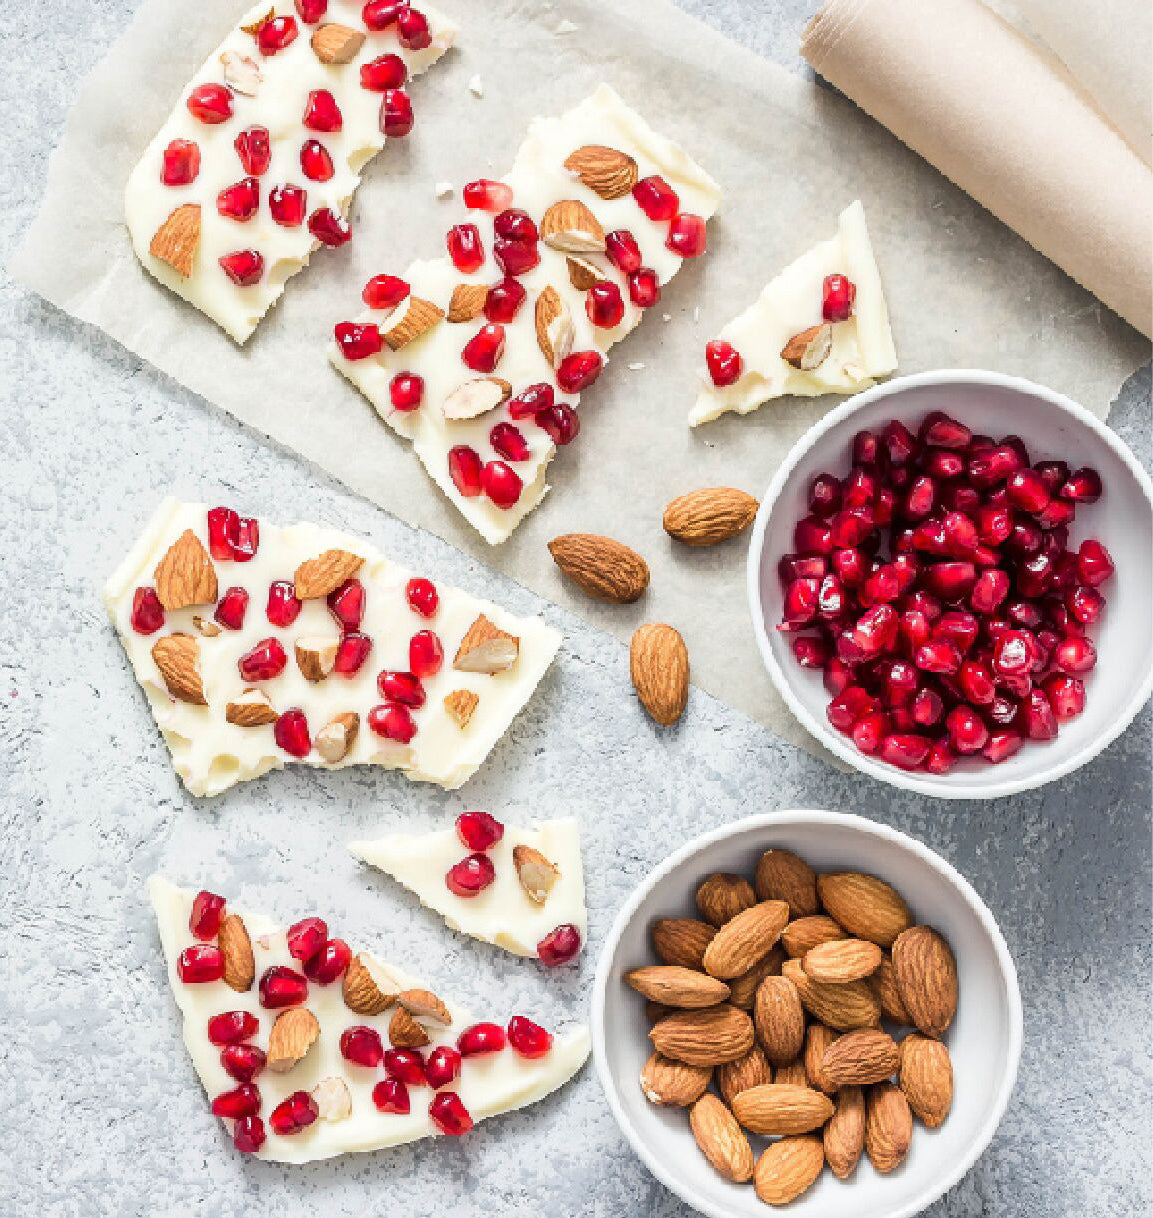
[11,0,1147,747]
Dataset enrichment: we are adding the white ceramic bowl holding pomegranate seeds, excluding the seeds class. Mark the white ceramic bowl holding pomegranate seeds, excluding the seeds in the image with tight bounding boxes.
[748,369,1153,799]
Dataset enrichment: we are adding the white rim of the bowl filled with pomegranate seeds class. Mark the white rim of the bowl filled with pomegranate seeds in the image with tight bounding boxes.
[745,368,1153,799]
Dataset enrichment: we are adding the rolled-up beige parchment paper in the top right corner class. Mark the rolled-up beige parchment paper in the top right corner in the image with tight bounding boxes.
[801,0,1153,337]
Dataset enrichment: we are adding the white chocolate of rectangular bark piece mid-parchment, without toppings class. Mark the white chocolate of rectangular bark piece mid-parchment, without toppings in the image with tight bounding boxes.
[330,85,721,544]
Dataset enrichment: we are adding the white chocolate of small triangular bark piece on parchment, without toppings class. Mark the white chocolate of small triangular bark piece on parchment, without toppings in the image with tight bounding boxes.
[689,200,897,428]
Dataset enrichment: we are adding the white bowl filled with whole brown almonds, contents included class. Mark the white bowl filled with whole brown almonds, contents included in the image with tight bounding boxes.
[593,811,1023,1218]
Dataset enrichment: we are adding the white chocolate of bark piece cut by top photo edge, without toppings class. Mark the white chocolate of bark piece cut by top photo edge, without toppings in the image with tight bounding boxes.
[124,0,457,343]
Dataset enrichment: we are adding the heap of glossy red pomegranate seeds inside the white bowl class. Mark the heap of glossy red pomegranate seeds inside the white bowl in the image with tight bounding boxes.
[777,409,1113,773]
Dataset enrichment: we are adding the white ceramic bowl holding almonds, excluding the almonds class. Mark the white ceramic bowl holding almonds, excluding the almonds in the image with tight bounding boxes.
[592,811,1022,1218]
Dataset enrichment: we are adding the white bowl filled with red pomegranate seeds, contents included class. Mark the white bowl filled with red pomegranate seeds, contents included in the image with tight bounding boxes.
[749,370,1153,799]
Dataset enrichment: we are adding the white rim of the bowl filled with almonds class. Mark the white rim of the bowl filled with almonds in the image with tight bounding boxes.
[589,809,1024,1218]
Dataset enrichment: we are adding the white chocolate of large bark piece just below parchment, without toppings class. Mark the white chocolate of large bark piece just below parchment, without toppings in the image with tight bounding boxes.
[105,499,560,795]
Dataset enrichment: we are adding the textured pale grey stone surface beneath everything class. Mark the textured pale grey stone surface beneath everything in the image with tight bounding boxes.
[0,0,1153,1218]
